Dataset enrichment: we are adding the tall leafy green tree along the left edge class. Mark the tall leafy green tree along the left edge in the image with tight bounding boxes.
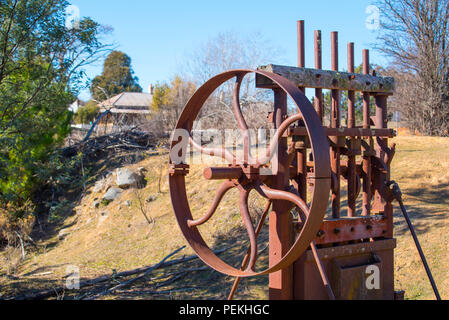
[0,0,110,213]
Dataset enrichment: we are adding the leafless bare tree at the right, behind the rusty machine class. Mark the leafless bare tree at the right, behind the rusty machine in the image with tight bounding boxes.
[379,0,449,136]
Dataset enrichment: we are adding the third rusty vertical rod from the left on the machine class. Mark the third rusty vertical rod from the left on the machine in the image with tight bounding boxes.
[331,32,341,219]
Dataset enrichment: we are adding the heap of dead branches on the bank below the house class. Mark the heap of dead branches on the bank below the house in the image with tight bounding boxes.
[63,129,164,158]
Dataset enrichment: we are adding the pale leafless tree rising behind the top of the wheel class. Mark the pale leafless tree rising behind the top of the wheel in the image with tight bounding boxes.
[181,32,281,129]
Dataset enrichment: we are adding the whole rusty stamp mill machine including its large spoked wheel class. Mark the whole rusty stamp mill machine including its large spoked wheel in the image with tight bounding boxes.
[169,21,396,300]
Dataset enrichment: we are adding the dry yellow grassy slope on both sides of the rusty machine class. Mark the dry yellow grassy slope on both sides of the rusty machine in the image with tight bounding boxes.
[0,137,449,299]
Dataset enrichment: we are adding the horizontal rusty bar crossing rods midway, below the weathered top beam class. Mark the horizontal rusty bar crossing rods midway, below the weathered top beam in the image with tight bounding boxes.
[287,127,396,138]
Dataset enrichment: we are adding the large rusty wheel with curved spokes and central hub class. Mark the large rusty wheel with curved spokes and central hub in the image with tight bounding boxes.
[169,70,331,277]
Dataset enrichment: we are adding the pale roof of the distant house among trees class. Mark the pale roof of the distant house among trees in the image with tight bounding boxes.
[99,92,153,114]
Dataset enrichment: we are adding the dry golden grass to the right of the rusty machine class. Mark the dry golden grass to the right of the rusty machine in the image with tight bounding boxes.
[392,137,449,299]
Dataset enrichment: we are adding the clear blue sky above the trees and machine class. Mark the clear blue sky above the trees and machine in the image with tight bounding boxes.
[71,0,386,99]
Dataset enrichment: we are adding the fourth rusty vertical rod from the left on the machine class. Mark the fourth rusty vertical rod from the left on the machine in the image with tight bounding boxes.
[348,42,357,217]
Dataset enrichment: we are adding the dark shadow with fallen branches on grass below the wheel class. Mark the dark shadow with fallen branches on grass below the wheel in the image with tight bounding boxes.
[0,222,268,300]
